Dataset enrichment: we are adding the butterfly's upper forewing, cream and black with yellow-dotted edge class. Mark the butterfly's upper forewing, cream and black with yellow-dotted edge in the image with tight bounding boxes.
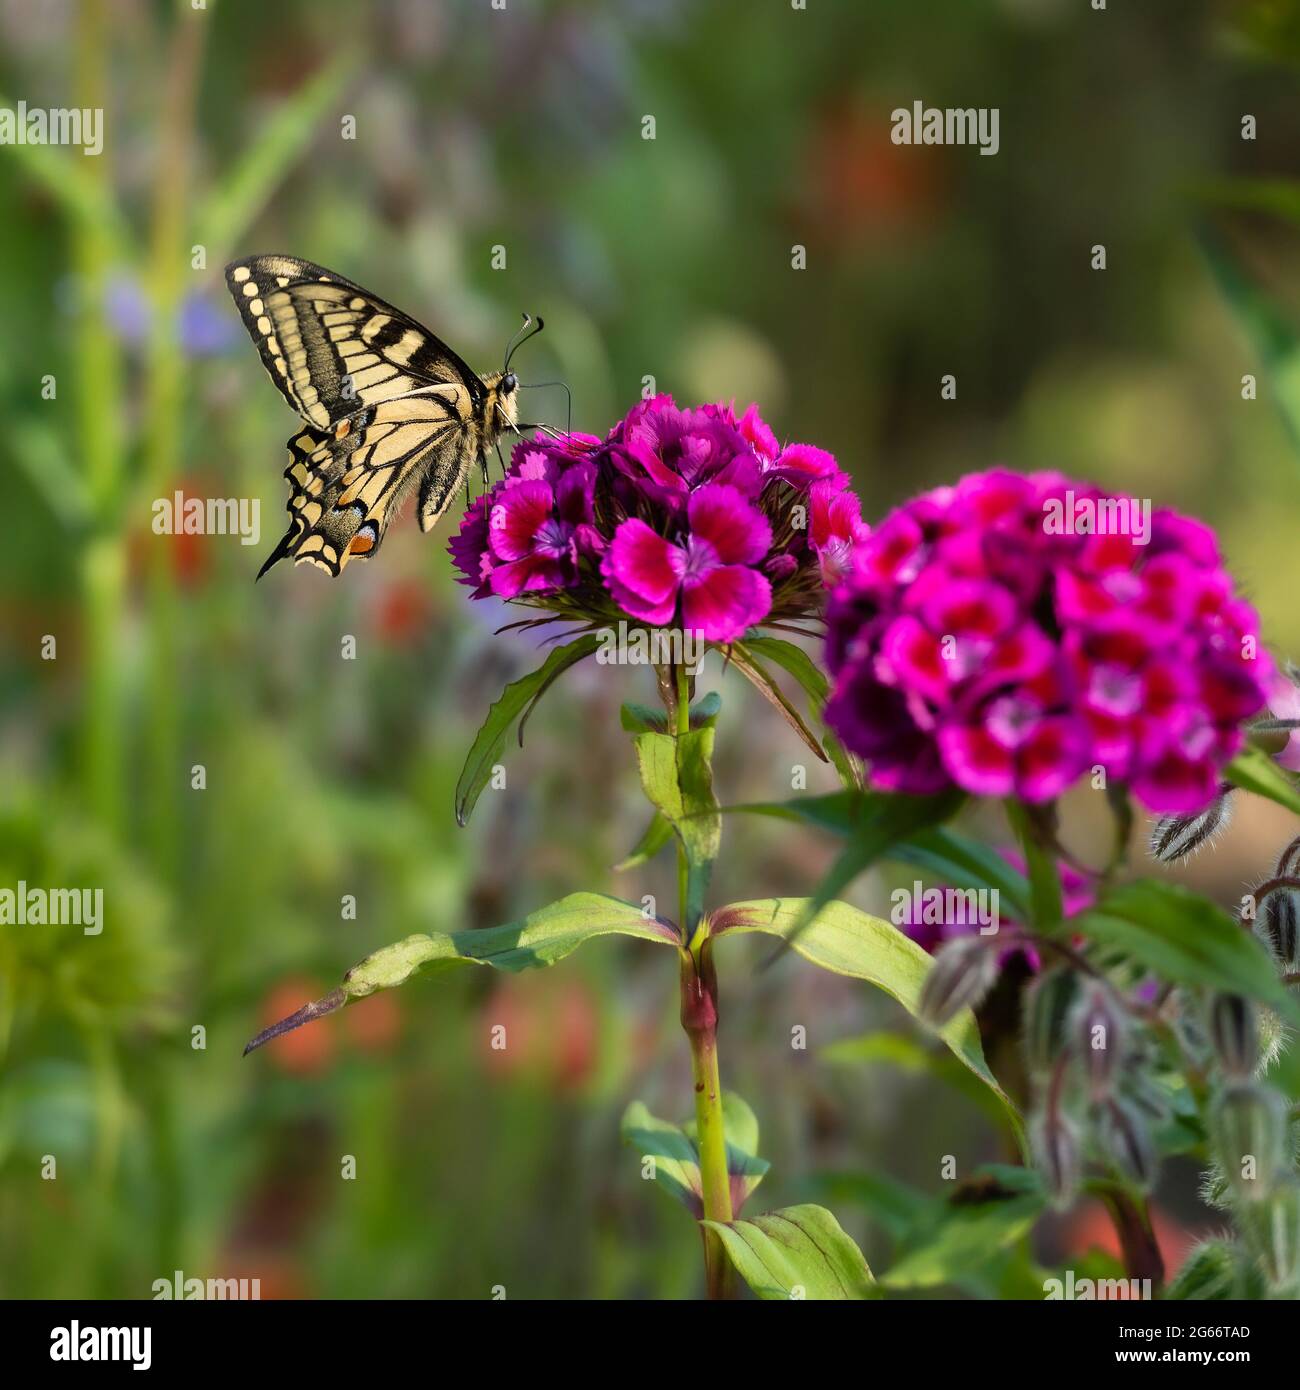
[225,256,485,430]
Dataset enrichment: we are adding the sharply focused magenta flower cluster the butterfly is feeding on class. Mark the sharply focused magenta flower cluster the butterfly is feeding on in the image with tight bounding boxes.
[450,396,868,644]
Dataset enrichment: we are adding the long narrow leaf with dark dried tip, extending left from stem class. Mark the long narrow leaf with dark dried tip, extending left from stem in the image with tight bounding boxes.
[243,892,681,1055]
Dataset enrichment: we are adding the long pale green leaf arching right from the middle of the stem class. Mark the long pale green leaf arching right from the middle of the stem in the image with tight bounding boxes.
[709,898,1023,1147]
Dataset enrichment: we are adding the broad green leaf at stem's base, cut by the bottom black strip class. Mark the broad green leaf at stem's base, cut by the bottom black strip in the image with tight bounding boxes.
[702,1205,877,1300]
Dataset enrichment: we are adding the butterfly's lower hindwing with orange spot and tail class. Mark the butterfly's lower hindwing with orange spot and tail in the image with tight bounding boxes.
[259,386,471,578]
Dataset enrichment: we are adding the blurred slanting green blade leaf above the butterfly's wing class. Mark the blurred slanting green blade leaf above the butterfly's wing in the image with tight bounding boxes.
[195,53,356,264]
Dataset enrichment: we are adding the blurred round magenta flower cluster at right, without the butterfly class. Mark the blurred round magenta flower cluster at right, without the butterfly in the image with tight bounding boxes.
[826,471,1274,812]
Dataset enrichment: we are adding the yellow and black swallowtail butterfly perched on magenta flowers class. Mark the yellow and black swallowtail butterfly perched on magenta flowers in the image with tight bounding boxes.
[225,256,542,580]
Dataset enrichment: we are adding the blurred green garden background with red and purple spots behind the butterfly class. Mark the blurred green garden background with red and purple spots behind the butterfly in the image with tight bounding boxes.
[0,0,1300,1298]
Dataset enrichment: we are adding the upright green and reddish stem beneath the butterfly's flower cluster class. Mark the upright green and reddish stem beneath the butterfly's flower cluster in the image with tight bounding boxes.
[673,664,731,1298]
